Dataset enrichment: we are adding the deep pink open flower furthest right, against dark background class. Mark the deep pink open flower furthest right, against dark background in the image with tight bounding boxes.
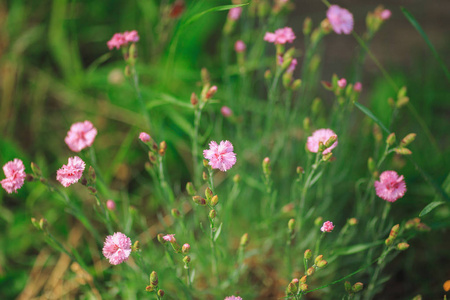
[375,171,406,202]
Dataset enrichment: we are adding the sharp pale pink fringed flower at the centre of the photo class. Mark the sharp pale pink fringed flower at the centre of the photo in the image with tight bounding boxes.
[203,141,236,172]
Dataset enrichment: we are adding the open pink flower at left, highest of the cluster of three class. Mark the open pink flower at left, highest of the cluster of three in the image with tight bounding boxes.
[64,121,97,152]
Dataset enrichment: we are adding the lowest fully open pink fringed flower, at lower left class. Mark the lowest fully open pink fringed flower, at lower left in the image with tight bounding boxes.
[102,232,131,265]
